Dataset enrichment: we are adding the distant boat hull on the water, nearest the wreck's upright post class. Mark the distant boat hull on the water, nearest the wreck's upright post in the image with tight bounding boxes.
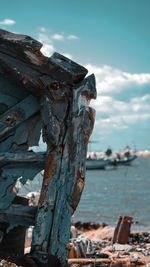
[86,158,110,170]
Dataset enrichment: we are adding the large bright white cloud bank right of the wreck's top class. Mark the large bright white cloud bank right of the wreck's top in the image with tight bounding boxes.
[86,64,150,134]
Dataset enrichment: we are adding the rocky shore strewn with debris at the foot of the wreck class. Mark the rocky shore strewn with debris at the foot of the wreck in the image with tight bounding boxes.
[0,222,150,267]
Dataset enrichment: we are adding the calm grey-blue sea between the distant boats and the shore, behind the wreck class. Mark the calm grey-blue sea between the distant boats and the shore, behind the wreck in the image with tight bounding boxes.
[20,157,150,231]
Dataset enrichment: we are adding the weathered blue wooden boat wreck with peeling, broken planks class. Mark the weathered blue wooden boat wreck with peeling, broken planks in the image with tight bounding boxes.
[0,30,96,266]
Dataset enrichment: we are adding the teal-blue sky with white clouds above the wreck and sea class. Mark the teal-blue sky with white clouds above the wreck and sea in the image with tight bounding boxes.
[0,0,150,151]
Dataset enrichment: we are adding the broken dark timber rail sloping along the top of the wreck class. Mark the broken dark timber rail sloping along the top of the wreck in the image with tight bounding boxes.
[0,29,88,90]
